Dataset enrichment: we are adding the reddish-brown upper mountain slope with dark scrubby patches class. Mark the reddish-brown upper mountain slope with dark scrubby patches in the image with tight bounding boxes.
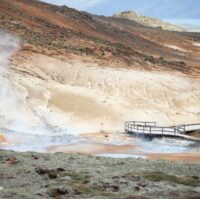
[0,0,200,74]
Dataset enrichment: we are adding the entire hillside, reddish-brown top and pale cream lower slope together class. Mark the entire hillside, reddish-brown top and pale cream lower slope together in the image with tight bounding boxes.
[0,0,200,133]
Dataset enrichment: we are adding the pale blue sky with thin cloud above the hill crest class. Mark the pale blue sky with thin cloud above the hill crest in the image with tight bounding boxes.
[43,0,200,19]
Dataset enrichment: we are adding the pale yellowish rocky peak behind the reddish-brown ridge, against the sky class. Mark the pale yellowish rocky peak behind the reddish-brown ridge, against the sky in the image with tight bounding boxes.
[114,10,184,31]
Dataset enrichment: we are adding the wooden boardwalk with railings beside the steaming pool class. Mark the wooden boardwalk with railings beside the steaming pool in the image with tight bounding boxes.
[125,121,200,141]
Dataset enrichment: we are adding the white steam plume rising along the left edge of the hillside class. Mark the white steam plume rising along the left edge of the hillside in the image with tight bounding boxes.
[0,32,50,133]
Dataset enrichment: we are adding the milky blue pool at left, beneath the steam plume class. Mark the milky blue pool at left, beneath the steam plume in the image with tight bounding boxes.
[0,128,86,152]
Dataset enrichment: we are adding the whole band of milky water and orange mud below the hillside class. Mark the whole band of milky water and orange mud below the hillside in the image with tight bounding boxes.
[0,129,200,162]
